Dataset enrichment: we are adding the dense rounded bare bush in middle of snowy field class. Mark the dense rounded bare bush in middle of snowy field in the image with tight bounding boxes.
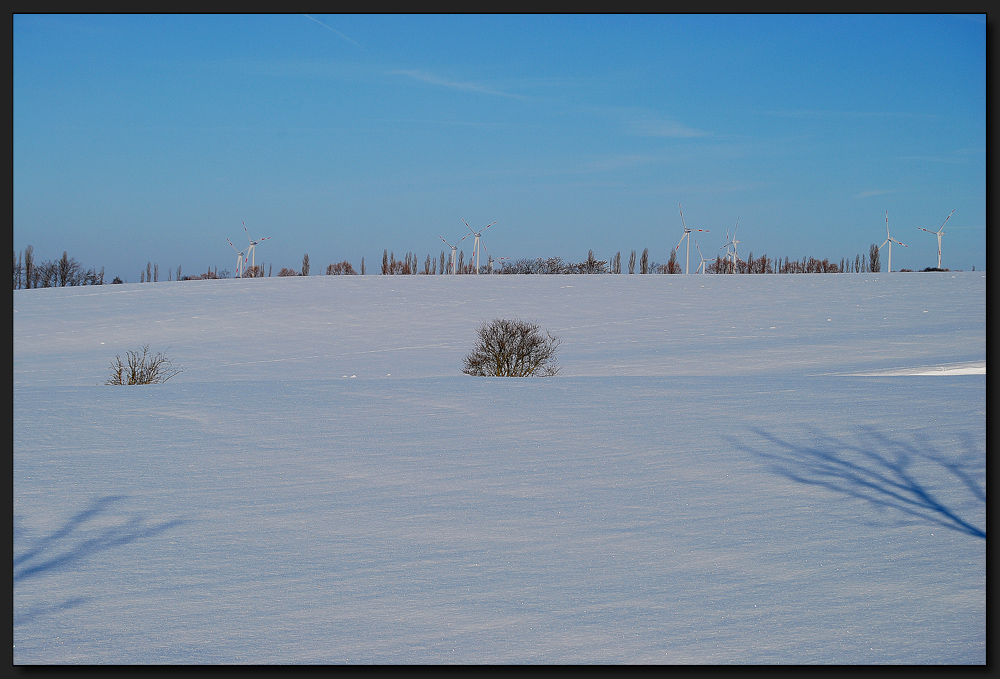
[462,318,560,377]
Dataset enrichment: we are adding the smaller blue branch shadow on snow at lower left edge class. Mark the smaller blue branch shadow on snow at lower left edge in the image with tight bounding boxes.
[14,495,185,584]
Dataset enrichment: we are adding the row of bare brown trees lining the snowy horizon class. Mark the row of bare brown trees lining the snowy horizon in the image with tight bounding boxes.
[13,243,948,290]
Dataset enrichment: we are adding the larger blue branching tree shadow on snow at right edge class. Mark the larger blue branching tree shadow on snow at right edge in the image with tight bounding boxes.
[734,428,986,540]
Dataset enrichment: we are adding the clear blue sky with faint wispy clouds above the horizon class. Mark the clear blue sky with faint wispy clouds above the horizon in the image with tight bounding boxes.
[13,14,986,282]
